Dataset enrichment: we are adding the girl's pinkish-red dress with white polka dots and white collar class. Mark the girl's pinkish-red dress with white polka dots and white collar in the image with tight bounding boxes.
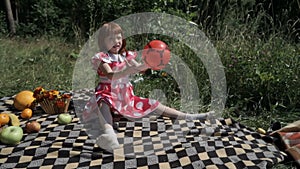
[83,51,159,118]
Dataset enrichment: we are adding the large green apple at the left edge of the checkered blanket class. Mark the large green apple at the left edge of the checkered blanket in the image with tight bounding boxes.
[0,126,23,145]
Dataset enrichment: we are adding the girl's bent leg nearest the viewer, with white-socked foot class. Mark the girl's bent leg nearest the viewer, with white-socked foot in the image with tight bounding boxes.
[96,102,120,151]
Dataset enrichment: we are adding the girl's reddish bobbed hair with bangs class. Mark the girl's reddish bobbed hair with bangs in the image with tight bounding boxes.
[98,22,126,53]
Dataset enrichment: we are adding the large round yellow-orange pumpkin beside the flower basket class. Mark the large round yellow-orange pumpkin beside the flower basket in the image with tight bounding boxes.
[14,90,35,110]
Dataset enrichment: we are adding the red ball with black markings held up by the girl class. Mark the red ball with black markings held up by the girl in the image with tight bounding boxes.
[142,40,171,70]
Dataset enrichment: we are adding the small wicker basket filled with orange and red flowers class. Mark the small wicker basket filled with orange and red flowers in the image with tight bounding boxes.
[33,87,71,114]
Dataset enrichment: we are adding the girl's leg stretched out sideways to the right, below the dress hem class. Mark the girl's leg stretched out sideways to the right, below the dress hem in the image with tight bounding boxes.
[155,104,210,120]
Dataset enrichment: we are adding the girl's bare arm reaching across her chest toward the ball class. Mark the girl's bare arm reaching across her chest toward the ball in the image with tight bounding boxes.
[99,60,149,80]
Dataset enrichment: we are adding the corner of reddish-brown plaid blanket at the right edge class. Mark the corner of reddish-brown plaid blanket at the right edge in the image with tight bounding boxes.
[270,120,300,166]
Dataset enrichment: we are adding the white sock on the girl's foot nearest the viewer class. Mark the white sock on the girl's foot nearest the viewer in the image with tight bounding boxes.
[96,128,120,151]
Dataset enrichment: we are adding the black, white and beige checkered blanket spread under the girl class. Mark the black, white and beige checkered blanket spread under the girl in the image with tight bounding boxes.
[0,89,286,169]
